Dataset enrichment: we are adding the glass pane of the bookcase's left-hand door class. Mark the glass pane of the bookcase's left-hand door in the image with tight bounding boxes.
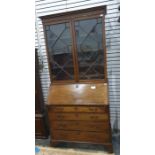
[45,23,74,80]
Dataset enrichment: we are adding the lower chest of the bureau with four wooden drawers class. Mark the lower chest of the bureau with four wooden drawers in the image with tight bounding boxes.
[48,105,112,152]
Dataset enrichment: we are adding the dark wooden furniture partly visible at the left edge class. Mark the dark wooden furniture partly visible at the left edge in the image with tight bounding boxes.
[35,50,48,139]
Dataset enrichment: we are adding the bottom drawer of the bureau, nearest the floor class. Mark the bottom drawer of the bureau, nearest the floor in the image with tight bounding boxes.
[52,130,110,143]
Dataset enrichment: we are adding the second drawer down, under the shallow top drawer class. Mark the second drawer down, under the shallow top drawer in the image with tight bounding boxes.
[49,113,108,121]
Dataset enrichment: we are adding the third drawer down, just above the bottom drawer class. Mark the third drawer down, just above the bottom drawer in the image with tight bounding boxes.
[51,121,110,132]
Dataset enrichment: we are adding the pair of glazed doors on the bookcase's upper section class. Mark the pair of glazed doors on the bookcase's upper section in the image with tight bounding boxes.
[44,15,106,82]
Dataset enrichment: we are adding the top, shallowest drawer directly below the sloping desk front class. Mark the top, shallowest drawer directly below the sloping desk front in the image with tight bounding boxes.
[48,106,108,113]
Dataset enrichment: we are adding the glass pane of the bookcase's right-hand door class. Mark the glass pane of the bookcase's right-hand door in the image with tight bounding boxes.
[75,18,104,79]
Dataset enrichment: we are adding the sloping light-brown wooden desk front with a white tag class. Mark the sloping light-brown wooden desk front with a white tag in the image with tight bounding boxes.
[48,83,108,105]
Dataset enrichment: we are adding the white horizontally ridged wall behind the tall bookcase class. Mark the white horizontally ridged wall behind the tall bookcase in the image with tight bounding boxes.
[35,0,120,130]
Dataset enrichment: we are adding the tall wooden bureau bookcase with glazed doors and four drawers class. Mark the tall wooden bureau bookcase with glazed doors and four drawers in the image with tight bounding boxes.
[41,6,112,152]
